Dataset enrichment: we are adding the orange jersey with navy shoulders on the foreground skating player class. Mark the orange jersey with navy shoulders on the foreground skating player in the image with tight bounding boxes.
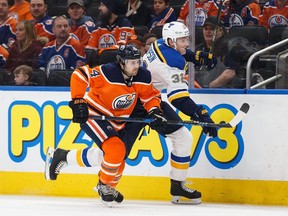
[70,62,160,131]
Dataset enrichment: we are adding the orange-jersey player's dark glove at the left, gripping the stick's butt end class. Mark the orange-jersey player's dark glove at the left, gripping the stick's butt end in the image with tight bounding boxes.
[69,98,89,124]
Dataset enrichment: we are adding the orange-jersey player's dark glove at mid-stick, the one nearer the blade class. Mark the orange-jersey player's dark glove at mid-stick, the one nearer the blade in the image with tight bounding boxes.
[148,108,167,132]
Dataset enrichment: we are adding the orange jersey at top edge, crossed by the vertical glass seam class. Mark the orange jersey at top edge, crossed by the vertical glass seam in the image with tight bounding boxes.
[178,0,225,26]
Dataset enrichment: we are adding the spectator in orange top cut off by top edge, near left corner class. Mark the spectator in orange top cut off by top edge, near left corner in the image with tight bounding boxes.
[9,0,33,21]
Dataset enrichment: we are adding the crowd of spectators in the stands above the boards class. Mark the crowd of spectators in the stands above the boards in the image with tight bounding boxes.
[0,0,288,88]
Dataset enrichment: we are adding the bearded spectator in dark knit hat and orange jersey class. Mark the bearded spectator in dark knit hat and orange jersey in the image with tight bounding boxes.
[86,0,135,51]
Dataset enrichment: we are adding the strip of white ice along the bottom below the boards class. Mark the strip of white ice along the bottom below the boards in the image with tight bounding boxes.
[0,195,288,216]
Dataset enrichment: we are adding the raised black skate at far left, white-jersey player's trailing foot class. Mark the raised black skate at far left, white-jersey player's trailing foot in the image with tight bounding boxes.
[45,147,69,180]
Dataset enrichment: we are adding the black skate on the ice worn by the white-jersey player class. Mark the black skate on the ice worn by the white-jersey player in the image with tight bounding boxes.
[170,179,201,205]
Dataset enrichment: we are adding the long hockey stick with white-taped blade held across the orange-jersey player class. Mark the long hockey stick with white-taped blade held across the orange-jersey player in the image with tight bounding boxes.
[89,103,250,128]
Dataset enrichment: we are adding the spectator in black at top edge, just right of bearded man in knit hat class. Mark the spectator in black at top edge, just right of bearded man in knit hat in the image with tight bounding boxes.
[126,0,152,26]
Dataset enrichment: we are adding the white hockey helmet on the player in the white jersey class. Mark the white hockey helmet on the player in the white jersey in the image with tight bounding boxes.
[162,21,190,46]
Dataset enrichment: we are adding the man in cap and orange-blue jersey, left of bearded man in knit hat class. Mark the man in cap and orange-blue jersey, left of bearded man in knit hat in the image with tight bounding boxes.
[67,0,95,47]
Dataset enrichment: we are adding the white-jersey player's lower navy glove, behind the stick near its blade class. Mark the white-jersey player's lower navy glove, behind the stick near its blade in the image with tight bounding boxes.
[191,106,217,137]
